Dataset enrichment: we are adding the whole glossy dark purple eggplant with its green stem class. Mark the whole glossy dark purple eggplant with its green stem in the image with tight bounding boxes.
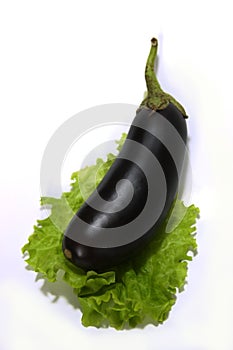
[62,38,187,272]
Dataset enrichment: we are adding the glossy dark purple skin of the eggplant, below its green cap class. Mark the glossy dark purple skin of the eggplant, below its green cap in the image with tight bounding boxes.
[62,103,187,272]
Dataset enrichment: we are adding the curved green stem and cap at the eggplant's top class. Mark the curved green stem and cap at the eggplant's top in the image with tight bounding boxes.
[140,38,187,118]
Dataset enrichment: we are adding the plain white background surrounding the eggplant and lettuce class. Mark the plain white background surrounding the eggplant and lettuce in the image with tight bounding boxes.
[0,0,233,350]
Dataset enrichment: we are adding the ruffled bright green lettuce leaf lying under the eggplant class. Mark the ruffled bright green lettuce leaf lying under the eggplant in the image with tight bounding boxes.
[22,134,199,329]
